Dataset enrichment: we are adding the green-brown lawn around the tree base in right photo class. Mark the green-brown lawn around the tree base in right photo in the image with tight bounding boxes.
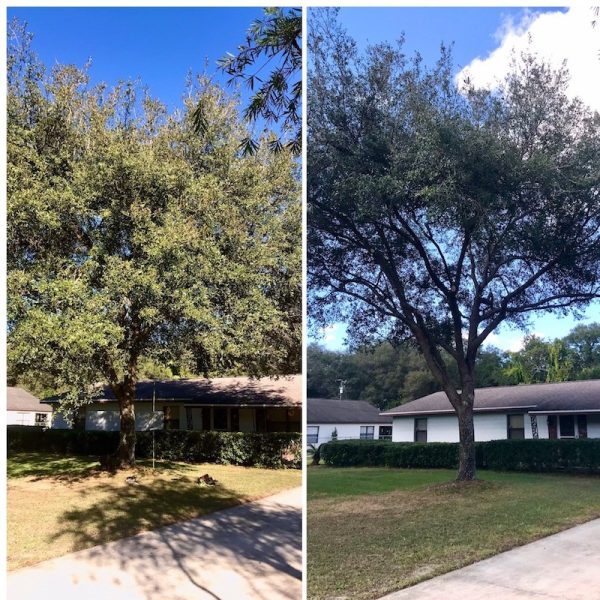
[308,466,600,600]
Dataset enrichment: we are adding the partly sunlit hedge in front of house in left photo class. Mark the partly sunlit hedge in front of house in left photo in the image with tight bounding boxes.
[7,425,302,468]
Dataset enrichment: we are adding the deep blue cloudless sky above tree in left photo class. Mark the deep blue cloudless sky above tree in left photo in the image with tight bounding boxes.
[8,7,262,110]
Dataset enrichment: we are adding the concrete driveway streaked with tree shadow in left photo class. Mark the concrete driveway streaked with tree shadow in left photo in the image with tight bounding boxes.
[8,488,302,600]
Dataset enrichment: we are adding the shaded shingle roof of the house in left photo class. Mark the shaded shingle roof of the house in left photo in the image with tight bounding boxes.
[47,375,302,406]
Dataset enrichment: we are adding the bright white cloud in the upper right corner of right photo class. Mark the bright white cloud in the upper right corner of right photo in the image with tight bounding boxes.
[457,6,600,111]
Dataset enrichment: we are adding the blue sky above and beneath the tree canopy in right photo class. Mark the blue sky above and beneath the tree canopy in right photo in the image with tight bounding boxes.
[313,7,600,350]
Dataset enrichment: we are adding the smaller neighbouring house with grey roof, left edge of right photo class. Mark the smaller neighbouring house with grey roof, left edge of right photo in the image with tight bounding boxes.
[306,398,392,445]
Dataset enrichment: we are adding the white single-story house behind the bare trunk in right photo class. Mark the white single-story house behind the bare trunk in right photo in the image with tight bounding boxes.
[382,379,600,442]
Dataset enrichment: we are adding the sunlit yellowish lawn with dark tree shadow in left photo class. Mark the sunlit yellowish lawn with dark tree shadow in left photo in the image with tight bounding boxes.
[7,453,302,570]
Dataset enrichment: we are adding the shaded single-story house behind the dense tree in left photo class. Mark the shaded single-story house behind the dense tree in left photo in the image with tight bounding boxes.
[46,375,302,433]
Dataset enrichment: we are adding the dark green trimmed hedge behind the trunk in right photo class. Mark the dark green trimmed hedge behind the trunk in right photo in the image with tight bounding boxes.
[320,440,600,472]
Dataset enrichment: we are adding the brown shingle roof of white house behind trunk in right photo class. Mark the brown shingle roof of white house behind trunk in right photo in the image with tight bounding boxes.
[383,379,600,416]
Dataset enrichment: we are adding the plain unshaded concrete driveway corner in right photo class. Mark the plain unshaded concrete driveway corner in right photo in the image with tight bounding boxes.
[381,519,600,600]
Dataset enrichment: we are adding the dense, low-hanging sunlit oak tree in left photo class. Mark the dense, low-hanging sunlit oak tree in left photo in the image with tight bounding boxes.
[8,23,301,464]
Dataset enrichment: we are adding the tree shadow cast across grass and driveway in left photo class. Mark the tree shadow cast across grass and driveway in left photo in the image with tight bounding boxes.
[51,477,302,600]
